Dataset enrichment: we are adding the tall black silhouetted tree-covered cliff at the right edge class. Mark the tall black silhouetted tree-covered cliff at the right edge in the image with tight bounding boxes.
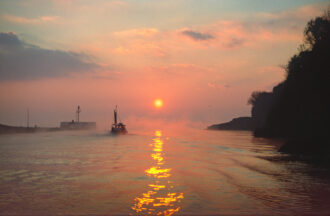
[248,10,330,152]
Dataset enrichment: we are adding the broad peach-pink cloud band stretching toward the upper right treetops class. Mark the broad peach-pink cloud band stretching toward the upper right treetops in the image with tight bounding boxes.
[179,4,324,50]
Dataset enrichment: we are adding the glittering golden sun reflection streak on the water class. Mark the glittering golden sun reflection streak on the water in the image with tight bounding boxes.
[132,131,184,216]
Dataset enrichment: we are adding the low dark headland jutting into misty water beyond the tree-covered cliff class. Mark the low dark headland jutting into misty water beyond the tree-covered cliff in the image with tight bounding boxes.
[207,117,255,131]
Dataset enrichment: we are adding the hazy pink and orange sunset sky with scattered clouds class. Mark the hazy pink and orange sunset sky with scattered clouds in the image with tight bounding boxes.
[0,0,329,128]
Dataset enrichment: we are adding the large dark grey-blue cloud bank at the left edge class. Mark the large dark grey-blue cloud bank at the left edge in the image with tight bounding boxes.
[0,32,101,81]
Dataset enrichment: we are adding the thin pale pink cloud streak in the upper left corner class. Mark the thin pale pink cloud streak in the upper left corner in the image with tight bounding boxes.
[2,14,59,24]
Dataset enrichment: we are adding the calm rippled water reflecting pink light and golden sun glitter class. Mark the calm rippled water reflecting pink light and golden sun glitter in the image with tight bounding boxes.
[0,130,330,215]
